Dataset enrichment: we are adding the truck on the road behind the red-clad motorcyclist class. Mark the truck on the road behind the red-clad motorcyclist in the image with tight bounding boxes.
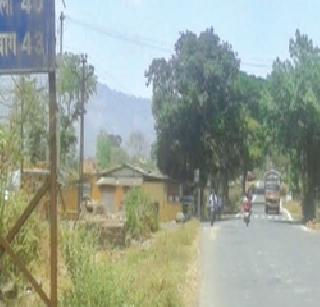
[264,170,281,214]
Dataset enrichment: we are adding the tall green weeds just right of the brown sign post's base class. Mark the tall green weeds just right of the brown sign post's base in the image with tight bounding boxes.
[60,224,131,306]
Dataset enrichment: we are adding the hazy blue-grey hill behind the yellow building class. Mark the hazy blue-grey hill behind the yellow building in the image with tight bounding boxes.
[85,83,155,157]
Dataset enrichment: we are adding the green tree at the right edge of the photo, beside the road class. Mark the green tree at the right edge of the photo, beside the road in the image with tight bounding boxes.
[269,30,320,221]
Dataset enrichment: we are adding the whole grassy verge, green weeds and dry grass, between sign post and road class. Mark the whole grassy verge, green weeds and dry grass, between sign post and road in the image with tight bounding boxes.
[60,221,199,307]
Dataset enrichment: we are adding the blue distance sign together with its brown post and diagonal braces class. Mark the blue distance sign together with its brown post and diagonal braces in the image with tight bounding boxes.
[0,0,58,306]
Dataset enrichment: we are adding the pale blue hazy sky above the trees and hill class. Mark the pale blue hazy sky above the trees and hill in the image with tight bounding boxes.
[56,0,320,97]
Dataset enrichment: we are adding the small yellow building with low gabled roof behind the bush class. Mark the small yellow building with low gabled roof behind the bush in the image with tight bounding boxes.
[97,164,182,221]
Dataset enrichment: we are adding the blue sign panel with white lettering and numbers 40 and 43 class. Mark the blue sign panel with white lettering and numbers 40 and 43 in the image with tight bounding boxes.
[0,0,55,74]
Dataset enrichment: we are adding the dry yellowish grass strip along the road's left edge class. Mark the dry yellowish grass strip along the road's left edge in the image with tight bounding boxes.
[112,221,199,306]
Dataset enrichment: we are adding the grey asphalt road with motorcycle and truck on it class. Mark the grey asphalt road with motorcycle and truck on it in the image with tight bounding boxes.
[199,204,320,307]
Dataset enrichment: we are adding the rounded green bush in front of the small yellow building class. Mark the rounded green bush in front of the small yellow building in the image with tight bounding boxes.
[125,188,159,239]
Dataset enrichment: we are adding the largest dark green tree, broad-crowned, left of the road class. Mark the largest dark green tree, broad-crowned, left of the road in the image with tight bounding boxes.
[146,28,240,205]
